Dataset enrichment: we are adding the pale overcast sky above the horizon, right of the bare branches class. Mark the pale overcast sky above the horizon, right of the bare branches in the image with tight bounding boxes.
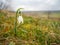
[0,0,60,11]
